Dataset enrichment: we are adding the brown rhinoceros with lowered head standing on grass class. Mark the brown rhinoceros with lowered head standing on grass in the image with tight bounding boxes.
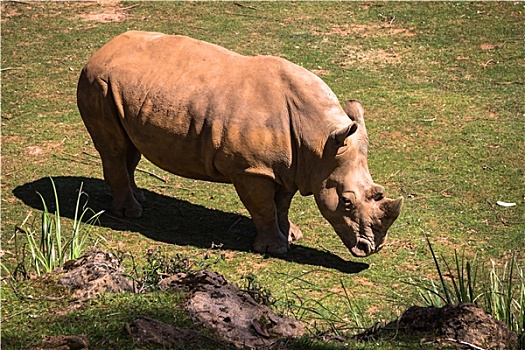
[77,31,403,257]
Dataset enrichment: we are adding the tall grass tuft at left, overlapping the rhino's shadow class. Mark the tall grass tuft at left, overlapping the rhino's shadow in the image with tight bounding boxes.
[2,178,104,278]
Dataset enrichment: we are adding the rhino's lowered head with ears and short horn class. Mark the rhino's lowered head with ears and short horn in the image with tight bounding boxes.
[314,101,403,257]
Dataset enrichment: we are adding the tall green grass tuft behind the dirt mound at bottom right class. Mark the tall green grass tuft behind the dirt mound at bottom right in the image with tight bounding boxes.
[410,237,525,348]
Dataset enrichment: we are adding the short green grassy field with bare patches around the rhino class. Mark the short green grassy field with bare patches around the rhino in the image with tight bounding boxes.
[1,1,525,349]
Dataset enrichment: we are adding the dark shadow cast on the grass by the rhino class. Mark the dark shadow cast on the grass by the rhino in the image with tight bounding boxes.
[13,176,369,273]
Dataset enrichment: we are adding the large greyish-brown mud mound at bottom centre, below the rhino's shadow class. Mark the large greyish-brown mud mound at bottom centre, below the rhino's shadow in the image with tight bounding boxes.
[160,271,304,349]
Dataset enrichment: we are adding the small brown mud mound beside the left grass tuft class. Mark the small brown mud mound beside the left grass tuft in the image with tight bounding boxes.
[57,250,133,301]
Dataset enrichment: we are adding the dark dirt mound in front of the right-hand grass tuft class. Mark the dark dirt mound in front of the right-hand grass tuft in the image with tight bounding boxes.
[356,304,518,349]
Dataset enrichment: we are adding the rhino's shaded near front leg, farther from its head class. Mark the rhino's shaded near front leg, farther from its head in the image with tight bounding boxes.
[234,175,288,255]
